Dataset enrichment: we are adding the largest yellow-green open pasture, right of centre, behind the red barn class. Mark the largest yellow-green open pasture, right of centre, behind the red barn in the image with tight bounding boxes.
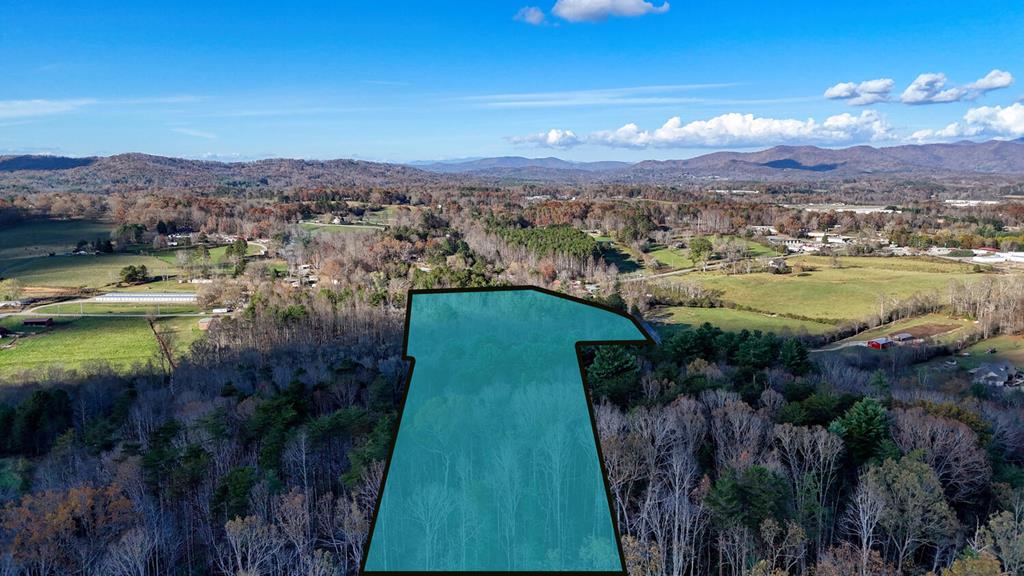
[667,256,976,324]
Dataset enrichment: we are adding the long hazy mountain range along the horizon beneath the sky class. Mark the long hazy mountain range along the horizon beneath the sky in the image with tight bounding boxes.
[0,138,1024,191]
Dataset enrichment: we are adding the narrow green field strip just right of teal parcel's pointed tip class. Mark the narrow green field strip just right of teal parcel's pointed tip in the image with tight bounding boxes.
[650,306,836,334]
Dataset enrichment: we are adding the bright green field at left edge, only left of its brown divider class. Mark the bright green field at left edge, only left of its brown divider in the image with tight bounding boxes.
[0,318,160,377]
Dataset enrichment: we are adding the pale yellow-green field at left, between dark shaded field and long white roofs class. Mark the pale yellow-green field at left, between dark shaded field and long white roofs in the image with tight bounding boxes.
[3,254,177,288]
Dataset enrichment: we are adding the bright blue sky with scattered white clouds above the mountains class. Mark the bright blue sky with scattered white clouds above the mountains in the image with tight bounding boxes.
[0,0,1024,161]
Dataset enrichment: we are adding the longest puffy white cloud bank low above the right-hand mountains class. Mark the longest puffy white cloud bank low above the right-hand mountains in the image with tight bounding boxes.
[512,111,892,149]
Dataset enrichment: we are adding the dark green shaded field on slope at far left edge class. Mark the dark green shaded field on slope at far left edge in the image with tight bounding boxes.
[0,220,114,276]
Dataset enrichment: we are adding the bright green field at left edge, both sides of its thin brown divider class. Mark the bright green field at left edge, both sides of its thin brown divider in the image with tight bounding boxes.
[0,317,202,378]
